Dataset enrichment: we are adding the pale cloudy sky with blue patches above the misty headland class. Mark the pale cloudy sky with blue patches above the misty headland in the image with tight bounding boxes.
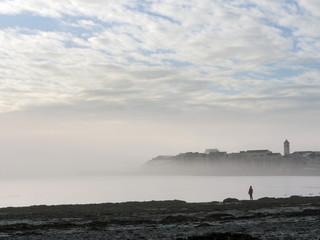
[0,0,320,177]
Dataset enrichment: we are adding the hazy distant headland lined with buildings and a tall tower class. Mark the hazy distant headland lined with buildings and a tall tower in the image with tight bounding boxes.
[143,140,320,176]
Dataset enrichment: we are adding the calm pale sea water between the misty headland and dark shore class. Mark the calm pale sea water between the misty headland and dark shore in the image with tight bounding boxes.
[0,176,320,207]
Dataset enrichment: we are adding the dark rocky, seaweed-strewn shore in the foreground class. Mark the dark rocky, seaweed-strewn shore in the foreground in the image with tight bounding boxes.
[0,196,320,240]
